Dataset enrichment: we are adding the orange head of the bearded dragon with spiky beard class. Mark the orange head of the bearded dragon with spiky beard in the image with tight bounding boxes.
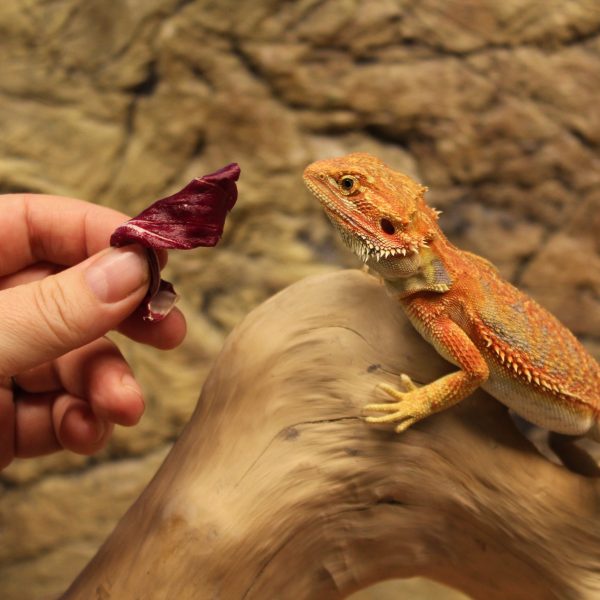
[304,152,439,278]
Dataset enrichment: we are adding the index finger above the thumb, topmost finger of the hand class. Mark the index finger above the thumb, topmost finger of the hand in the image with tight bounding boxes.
[0,194,129,276]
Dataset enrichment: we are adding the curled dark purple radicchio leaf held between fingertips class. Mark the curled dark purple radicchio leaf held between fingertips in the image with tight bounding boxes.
[110,163,240,321]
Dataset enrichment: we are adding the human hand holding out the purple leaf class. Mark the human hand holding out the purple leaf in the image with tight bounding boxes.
[0,194,185,469]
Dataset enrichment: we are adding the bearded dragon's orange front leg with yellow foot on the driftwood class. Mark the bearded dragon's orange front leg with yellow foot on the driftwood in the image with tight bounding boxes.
[363,318,489,433]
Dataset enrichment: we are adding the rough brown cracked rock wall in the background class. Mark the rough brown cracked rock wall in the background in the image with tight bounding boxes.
[0,0,600,600]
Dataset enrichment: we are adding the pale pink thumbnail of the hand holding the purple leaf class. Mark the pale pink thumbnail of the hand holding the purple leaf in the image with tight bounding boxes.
[85,246,149,302]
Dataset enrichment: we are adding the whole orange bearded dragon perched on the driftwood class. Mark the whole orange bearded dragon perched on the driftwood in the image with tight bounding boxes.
[304,153,600,441]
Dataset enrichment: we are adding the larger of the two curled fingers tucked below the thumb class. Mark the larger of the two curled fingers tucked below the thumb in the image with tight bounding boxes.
[55,338,144,425]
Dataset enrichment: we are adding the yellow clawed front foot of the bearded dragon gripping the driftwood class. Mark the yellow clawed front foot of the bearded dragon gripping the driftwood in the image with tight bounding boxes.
[362,374,430,433]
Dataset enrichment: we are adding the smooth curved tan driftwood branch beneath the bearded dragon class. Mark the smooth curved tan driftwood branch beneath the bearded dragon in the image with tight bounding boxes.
[59,271,600,600]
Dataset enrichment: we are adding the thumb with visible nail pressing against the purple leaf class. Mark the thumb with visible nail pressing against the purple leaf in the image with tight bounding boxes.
[0,246,149,376]
